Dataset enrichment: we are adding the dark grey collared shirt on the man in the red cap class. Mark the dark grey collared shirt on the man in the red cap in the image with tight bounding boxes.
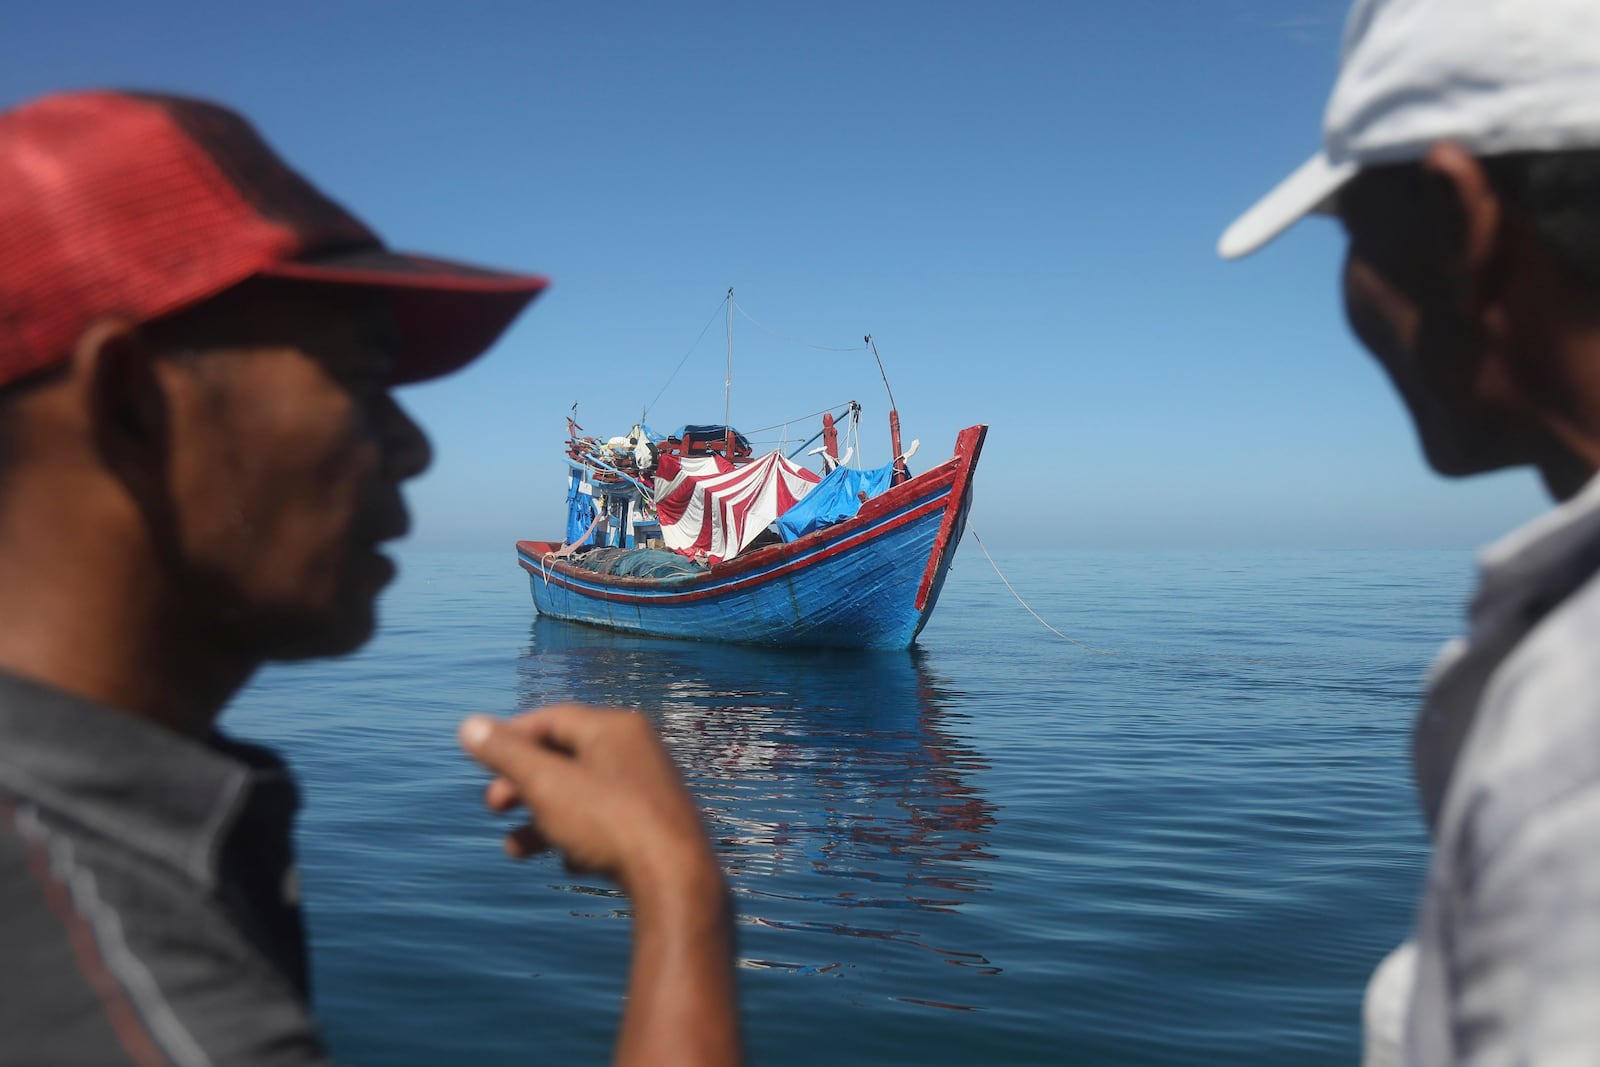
[0,673,326,1067]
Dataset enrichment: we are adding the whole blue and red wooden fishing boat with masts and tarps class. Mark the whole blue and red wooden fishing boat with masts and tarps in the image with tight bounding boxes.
[517,290,987,649]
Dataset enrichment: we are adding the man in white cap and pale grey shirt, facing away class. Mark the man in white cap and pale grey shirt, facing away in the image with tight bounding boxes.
[1219,0,1600,1064]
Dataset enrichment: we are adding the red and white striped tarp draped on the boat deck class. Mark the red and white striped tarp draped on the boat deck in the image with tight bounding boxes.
[656,451,821,563]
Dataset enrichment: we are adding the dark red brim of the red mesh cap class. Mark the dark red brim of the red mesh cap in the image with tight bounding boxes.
[261,248,549,386]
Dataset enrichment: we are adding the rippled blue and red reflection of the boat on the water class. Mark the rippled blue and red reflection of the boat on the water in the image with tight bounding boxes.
[518,617,998,1008]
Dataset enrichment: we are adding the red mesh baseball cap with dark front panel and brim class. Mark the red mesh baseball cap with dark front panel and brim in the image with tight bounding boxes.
[0,93,547,386]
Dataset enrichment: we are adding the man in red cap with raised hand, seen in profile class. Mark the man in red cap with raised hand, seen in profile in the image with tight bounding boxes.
[0,93,739,1067]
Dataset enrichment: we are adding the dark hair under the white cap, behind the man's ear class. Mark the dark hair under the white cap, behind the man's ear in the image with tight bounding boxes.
[1480,149,1600,290]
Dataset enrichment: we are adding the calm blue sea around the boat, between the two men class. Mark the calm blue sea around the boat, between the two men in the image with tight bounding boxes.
[227,550,1472,1067]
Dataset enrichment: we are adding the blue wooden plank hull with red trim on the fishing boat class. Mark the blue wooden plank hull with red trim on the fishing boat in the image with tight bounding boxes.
[517,426,987,649]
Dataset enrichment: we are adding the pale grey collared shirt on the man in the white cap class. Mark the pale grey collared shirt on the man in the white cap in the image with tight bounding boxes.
[1368,478,1600,1067]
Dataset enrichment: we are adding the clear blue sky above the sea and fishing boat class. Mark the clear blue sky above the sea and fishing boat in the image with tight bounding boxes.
[0,0,1542,547]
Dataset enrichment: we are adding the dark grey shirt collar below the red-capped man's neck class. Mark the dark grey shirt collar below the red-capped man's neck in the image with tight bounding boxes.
[0,672,296,886]
